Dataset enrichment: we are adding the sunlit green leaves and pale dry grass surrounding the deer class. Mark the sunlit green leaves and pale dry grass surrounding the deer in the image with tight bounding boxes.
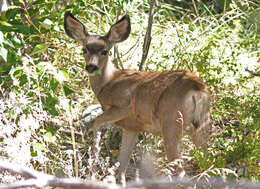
[0,0,260,186]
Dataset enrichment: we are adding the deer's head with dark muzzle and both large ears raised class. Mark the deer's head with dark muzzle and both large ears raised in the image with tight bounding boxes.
[64,12,131,75]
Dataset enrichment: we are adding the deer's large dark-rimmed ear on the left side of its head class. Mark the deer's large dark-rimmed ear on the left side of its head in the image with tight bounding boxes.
[64,12,88,42]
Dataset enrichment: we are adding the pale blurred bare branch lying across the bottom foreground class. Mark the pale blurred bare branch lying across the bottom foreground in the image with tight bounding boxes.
[0,161,260,189]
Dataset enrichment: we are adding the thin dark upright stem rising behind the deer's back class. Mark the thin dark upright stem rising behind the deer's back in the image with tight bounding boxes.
[139,0,154,71]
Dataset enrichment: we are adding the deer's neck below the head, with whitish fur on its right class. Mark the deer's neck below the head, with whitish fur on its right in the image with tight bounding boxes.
[89,60,118,96]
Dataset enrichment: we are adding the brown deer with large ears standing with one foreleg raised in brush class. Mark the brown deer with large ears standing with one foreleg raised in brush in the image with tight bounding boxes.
[64,12,211,174]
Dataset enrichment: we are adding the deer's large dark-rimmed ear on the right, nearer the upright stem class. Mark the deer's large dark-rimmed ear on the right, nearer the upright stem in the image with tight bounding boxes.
[107,15,131,43]
